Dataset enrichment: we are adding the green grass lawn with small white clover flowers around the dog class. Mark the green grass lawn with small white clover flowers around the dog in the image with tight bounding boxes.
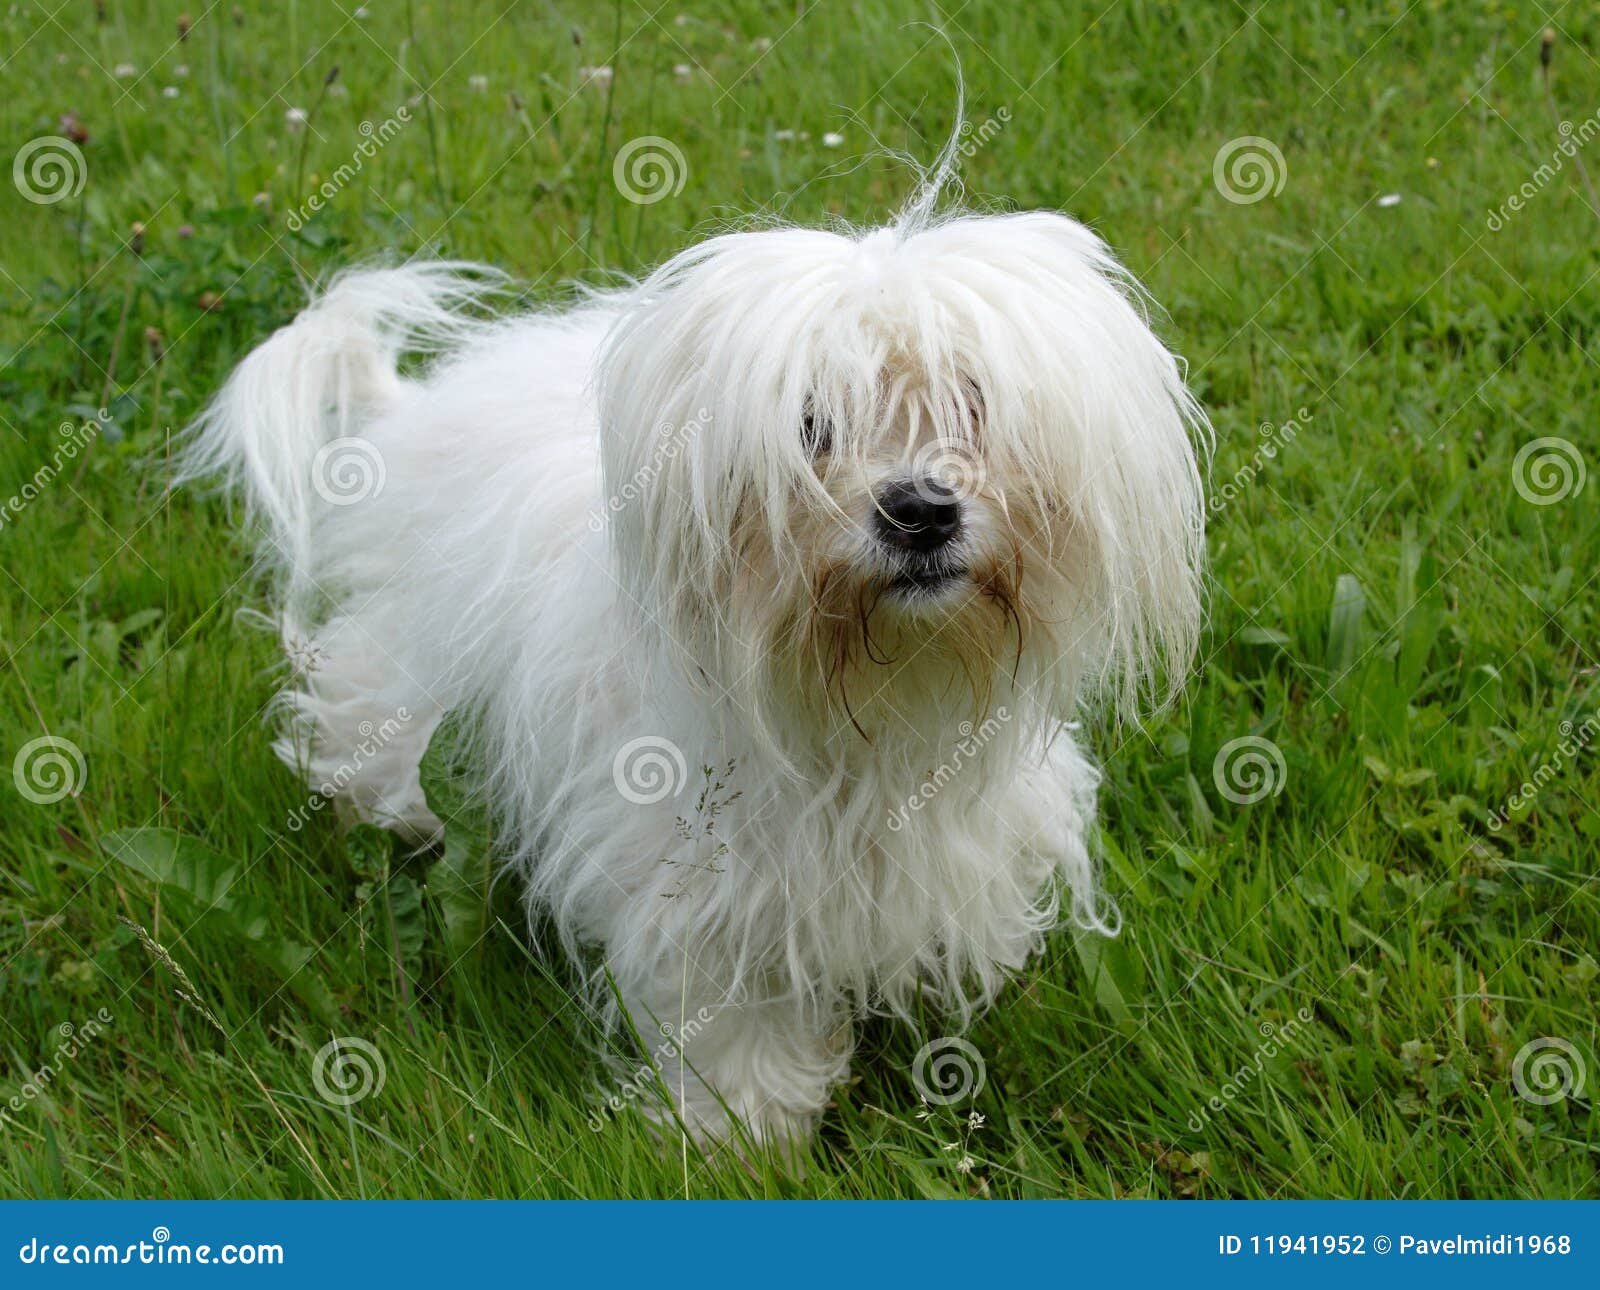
[0,0,1600,1197]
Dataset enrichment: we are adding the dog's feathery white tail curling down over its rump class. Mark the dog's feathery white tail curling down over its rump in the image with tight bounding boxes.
[178,262,502,603]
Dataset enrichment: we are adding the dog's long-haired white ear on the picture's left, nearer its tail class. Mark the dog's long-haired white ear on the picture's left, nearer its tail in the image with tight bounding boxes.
[597,229,851,688]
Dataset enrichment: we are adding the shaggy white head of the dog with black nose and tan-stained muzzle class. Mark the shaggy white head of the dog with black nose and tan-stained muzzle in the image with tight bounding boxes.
[600,213,1205,749]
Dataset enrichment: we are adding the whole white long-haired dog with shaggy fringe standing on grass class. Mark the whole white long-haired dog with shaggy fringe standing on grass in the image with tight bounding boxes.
[189,181,1208,1141]
